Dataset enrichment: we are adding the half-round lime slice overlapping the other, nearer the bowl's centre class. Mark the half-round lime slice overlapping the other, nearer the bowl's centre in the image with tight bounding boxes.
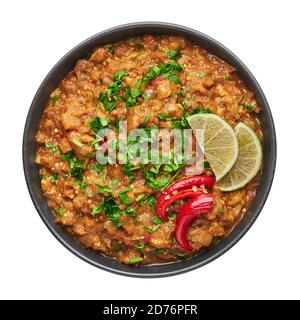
[187,113,238,181]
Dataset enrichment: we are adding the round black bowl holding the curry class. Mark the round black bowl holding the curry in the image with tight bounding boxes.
[23,22,276,278]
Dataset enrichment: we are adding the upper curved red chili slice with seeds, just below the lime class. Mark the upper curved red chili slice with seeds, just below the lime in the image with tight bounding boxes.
[156,175,215,221]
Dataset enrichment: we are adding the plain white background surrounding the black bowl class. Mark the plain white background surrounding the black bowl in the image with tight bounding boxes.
[0,0,300,299]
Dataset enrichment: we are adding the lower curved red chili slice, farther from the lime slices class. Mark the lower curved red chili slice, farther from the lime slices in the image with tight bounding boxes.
[175,193,213,251]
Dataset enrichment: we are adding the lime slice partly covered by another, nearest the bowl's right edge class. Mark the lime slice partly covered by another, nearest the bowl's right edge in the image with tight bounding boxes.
[217,123,262,191]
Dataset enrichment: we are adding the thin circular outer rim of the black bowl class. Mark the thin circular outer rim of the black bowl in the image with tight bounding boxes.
[22,21,277,278]
